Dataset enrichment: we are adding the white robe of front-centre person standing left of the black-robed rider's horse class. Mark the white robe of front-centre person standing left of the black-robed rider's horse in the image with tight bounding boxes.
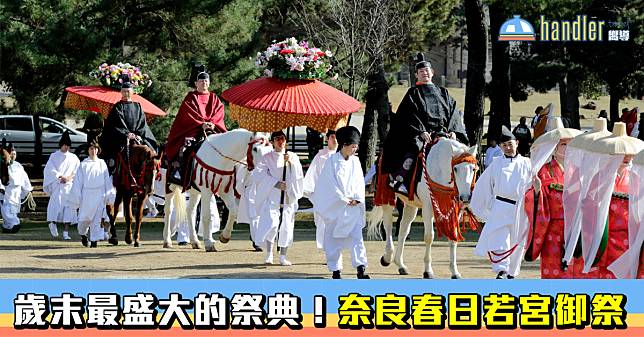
[313,153,367,271]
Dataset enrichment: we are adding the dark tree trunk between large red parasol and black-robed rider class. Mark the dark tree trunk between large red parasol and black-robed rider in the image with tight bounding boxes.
[358,59,389,172]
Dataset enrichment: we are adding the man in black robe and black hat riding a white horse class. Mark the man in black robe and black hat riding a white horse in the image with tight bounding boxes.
[382,54,468,194]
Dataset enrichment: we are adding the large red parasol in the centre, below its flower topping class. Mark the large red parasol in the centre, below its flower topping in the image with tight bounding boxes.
[222,78,361,132]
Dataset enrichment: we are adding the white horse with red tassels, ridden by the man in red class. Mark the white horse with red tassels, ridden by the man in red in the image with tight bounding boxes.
[163,129,265,252]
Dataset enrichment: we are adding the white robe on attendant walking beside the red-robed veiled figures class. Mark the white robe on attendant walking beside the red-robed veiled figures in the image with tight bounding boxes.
[470,155,532,276]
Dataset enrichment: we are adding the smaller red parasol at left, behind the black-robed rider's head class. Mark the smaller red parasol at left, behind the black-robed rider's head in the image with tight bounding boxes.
[65,86,165,118]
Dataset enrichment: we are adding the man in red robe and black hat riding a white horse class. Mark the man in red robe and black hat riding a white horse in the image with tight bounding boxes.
[166,65,226,187]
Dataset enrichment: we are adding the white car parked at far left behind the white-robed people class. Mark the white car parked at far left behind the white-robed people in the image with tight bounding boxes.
[0,115,87,163]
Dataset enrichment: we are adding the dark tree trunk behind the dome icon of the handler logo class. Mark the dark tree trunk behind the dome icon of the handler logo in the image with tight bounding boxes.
[487,3,511,139]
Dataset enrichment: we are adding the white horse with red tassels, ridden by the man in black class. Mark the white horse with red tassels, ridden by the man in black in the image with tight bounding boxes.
[368,138,477,279]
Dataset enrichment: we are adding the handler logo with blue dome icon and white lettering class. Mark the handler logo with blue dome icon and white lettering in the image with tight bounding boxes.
[499,15,606,42]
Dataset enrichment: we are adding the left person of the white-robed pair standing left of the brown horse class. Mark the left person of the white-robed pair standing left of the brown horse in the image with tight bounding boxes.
[43,131,80,240]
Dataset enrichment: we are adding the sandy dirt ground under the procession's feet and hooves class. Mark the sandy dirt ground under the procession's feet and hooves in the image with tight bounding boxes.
[0,222,539,279]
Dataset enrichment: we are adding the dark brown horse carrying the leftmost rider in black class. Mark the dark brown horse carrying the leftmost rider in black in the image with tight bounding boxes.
[107,145,161,247]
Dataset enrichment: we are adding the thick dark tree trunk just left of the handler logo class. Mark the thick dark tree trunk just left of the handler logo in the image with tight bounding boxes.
[461,0,487,144]
